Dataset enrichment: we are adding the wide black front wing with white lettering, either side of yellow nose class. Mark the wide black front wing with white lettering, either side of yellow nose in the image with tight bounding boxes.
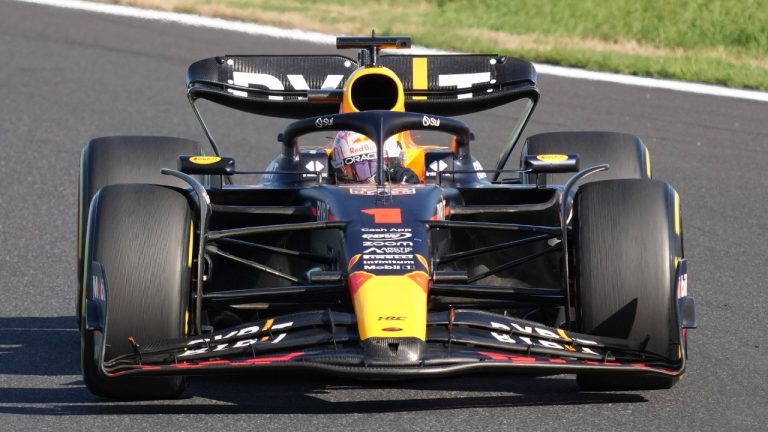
[96,310,685,379]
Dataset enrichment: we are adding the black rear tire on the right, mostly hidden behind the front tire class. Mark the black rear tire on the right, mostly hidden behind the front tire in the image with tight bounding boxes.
[522,132,651,185]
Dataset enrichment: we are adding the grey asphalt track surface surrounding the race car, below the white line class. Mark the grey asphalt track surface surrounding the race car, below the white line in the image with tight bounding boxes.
[0,1,768,431]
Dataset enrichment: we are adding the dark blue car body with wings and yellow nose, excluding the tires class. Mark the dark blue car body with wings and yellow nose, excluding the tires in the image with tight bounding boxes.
[82,38,695,392]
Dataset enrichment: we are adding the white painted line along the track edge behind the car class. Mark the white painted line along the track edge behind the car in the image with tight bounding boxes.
[15,0,768,102]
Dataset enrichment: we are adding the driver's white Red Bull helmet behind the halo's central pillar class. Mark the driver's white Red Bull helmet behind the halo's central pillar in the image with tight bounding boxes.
[331,131,405,184]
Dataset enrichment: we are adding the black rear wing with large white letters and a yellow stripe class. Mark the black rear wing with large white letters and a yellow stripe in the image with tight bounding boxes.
[187,55,539,119]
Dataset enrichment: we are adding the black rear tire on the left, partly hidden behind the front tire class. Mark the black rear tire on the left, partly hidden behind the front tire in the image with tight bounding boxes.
[76,136,202,321]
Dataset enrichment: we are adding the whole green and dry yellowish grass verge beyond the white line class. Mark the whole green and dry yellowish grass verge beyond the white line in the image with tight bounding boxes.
[103,0,768,90]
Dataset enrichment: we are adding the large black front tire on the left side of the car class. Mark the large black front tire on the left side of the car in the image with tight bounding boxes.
[81,184,193,399]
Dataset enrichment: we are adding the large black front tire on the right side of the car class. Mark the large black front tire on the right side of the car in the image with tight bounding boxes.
[574,179,683,390]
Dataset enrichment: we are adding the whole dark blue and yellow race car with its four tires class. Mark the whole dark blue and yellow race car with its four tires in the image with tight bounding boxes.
[77,35,695,399]
